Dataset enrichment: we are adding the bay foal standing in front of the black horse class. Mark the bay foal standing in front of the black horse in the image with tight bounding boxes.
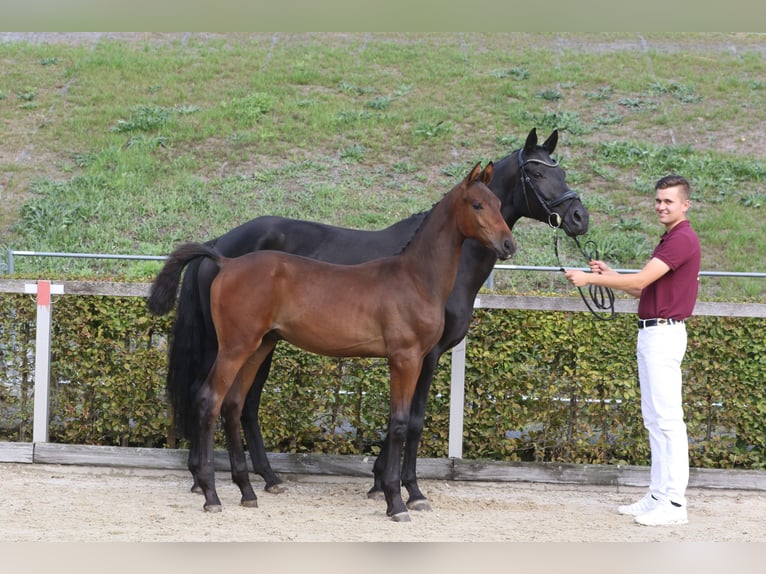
[170,162,516,522]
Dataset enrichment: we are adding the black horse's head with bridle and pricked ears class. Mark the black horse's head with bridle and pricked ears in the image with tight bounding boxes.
[515,128,590,236]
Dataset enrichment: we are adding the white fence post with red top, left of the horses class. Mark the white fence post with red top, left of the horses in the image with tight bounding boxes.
[24,281,64,442]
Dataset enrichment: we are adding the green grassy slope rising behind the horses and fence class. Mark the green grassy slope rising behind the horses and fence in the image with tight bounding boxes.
[0,34,766,300]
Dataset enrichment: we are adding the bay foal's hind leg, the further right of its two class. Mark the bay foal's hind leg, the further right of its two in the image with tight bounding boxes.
[221,341,276,508]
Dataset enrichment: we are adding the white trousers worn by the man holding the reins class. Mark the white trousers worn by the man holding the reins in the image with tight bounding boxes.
[636,324,689,506]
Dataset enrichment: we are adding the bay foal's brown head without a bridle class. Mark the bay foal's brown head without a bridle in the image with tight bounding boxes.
[457,162,516,259]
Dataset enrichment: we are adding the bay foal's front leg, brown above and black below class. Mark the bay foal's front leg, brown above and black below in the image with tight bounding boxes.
[383,353,420,522]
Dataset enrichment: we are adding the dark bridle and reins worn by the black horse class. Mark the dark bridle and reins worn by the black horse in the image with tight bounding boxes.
[518,149,614,321]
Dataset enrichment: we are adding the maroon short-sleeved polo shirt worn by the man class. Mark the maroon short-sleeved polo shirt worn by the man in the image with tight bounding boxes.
[638,220,701,321]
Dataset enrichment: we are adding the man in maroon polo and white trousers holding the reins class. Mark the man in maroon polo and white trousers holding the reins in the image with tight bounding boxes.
[566,175,700,526]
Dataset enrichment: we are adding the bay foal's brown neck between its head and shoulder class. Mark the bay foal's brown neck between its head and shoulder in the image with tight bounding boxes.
[402,194,466,301]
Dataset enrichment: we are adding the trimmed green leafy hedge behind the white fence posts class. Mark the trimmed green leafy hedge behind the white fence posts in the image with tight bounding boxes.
[0,295,766,469]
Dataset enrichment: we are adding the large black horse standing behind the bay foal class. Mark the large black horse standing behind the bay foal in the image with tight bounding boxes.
[148,128,589,510]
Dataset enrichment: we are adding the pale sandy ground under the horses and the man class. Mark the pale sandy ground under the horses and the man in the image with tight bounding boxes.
[0,463,766,542]
